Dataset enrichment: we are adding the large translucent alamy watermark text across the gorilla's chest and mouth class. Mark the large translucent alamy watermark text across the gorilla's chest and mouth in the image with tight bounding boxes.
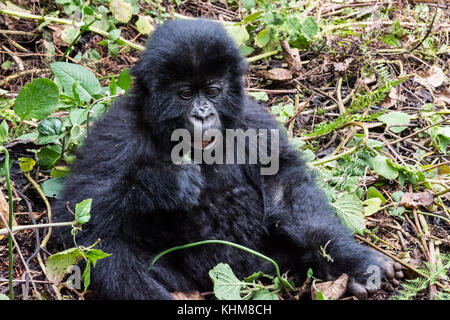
[171,127,280,175]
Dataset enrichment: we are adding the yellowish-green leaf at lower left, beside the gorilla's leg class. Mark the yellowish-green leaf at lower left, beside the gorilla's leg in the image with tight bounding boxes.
[46,248,83,283]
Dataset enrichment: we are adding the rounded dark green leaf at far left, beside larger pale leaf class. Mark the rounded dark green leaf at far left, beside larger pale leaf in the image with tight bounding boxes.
[14,79,59,121]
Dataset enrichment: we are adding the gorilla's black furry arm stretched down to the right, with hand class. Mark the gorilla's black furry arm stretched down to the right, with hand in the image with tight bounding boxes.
[241,104,402,298]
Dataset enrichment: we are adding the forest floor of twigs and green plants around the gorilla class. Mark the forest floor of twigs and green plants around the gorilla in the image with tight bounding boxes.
[0,0,450,300]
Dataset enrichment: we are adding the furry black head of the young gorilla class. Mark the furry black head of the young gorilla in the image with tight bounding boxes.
[132,20,247,148]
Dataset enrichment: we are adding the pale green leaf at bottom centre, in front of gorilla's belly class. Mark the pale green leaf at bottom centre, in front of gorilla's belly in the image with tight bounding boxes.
[209,263,246,300]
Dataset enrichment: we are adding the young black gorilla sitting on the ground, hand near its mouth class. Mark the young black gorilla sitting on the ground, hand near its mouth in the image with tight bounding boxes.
[54,20,402,299]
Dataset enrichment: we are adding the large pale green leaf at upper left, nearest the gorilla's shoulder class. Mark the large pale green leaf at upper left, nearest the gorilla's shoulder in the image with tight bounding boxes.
[50,62,102,102]
